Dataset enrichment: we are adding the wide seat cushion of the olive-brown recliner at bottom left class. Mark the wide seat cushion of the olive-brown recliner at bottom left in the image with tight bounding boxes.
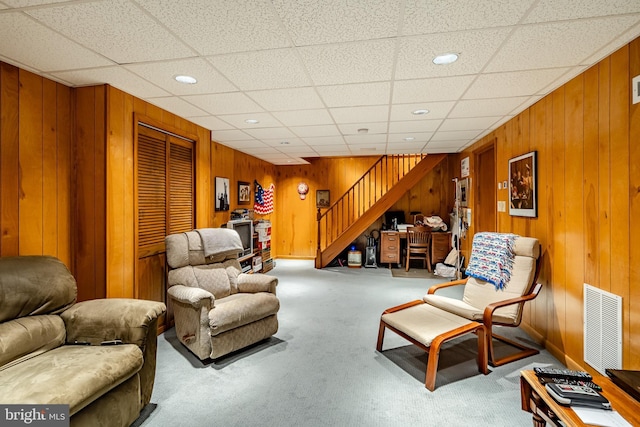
[0,344,143,415]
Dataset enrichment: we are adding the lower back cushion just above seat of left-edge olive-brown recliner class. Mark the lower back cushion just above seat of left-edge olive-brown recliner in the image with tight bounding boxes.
[0,314,66,371]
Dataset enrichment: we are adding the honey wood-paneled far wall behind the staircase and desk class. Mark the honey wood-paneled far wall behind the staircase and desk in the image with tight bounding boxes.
[276,156,455,259]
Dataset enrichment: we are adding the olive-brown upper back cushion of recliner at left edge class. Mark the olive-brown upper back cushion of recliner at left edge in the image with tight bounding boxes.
[0,255,77,322]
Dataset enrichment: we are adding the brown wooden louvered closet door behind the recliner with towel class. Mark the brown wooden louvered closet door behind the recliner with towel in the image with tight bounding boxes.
[136,126,194,329]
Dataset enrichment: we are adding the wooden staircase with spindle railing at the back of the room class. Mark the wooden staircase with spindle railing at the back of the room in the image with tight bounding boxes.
[315,154,446,268]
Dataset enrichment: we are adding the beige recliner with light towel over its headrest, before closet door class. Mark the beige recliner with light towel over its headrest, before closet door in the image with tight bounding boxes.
[165,228,280,360]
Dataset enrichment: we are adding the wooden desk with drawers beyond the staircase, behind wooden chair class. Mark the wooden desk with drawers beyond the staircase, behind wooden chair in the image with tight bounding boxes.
[380,230,451,267]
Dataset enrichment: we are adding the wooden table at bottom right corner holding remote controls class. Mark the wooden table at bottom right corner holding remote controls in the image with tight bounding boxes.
[520,371,640,427]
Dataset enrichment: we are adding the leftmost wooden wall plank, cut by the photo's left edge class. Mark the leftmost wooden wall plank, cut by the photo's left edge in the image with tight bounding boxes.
[0,62,20,256]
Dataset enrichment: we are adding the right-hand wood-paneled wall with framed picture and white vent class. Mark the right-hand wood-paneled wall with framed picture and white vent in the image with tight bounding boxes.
[456,39,640,369]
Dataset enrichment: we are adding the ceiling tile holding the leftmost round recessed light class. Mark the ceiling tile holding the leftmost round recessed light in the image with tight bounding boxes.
[125,58,238,95]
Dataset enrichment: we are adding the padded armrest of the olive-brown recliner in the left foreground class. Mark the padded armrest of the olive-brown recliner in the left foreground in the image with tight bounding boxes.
[60,298,167,349]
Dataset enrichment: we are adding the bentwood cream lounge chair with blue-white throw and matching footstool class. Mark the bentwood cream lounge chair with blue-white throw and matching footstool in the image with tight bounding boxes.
[376,233,542,391]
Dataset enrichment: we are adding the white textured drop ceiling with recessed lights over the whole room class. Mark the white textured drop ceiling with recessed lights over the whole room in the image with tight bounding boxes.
[0,0,640,165]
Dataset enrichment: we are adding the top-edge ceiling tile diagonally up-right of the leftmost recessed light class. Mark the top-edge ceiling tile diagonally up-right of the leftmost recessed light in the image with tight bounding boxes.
[137,0,291,55]
